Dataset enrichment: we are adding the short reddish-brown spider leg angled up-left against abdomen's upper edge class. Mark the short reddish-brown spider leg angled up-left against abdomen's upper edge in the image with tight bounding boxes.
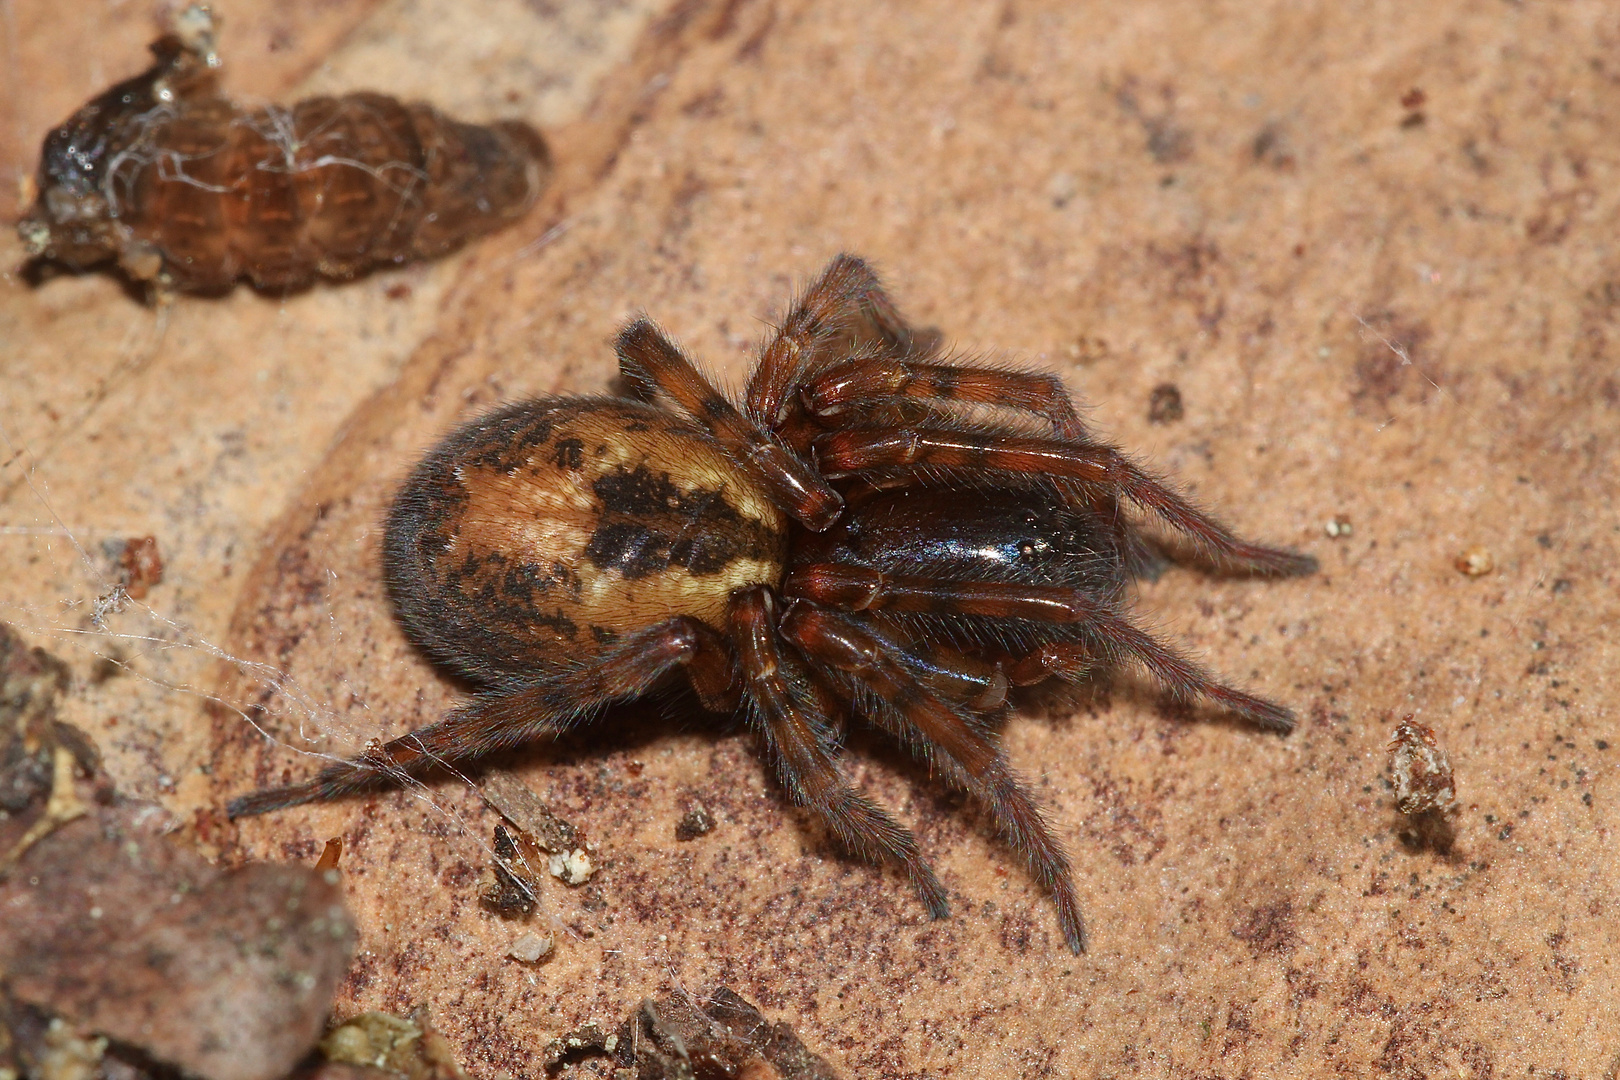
[614,319,844,533]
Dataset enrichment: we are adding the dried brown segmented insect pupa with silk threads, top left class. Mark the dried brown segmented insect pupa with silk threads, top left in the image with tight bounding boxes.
[18,5,551,291]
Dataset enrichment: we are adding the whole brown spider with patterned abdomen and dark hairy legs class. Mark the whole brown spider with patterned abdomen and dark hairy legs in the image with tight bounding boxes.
[230,254,1315,952]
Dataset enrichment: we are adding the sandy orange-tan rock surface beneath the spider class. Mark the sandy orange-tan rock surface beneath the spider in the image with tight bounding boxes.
[0,0,1620,1077]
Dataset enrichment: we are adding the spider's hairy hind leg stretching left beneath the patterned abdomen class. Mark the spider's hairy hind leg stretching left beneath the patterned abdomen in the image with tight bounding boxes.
[225,615,740,818]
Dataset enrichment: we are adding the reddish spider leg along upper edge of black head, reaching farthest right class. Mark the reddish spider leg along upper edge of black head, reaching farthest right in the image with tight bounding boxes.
[815,427,1317,576]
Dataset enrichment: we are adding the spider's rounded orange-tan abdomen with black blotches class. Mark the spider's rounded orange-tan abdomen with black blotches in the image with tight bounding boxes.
[384,398,787,682]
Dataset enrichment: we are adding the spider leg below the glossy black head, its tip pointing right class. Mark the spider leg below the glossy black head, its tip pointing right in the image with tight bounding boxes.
[782,563,1294,732]
